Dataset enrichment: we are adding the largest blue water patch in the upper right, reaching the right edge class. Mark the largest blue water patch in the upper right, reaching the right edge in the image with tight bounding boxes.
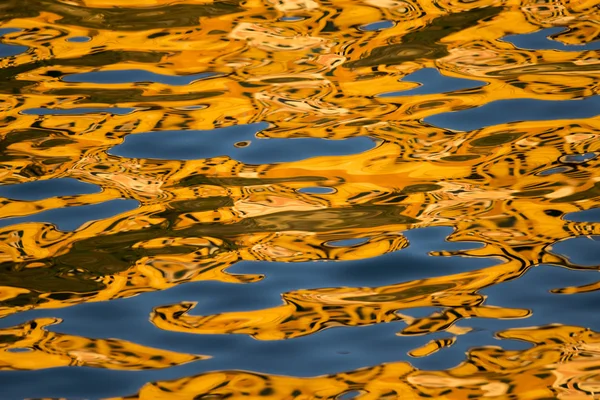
[425,96,600,131]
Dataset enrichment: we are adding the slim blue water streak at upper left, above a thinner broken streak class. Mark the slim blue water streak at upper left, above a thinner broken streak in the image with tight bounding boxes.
[63,69,219,86]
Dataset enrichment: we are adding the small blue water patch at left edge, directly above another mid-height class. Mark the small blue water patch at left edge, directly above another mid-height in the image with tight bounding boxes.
[0,178,100,200]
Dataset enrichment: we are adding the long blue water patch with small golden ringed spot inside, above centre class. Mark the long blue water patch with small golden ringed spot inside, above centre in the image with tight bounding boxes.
[109,122,375,164]
